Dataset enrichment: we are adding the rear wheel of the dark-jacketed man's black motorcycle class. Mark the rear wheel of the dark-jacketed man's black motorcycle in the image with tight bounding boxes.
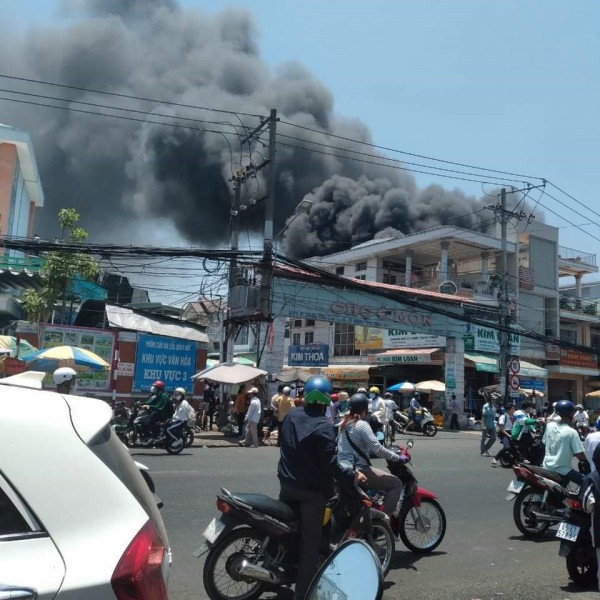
[202,527,267,600]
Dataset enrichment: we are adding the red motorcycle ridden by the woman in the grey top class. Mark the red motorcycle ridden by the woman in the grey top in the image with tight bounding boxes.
[367,440,446,554]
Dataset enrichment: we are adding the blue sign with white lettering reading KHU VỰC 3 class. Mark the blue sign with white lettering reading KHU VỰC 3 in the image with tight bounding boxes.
[133,335,196,394]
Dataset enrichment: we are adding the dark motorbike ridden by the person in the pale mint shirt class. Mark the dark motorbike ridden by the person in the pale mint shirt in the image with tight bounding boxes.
[506,463,579,538]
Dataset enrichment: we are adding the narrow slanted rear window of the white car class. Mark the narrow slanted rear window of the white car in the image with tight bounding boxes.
[88,425,167,545]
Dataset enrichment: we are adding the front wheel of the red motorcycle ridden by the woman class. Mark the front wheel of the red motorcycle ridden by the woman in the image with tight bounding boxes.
[398,498,446,554]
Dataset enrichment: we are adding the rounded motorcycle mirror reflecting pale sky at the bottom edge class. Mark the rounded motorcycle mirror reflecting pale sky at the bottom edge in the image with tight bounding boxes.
[305,539,383,600]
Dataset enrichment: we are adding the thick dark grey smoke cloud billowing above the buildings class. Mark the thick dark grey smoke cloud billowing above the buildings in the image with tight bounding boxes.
[0,0,496,257]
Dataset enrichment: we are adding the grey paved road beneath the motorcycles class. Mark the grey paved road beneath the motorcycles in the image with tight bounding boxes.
[132,432,599,600]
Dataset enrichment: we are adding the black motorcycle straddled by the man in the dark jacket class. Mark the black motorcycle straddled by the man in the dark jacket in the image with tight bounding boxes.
[194,484,395,600]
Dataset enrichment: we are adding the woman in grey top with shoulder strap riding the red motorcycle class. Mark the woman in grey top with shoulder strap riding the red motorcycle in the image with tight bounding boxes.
[338,394,408,533]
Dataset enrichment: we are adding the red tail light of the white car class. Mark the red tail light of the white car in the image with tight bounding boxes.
[110,521,168,600]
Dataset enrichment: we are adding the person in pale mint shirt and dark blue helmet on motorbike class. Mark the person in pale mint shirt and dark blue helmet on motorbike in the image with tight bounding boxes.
[542,400,587,484]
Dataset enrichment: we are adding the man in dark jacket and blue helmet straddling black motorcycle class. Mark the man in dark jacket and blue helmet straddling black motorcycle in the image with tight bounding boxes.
[277,376,366,600]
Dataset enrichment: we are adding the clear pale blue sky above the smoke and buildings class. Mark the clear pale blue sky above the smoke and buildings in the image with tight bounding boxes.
[0,0,600,298]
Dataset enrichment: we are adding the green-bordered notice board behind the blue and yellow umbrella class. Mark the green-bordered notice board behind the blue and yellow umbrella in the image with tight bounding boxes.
[40,325,115,392]
